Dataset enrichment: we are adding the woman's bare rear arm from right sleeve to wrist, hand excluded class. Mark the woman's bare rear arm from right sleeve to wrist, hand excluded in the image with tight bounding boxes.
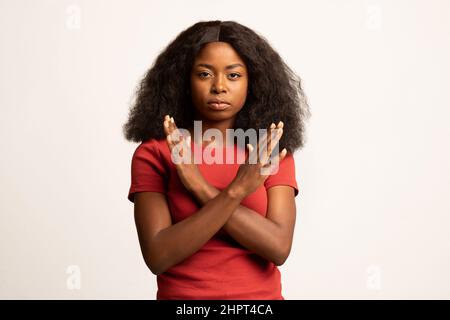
[192,183,296,266]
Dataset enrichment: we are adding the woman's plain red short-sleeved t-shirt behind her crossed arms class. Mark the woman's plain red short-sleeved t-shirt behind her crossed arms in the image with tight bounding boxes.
[128,139,298,300]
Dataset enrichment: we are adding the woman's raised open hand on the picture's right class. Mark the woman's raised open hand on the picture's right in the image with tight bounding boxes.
[229,121,287,199]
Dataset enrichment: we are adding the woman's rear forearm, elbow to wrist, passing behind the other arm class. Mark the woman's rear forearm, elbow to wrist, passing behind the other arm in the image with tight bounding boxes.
[192,183,286,265]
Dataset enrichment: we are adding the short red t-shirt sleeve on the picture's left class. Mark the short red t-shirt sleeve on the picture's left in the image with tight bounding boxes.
[128,144,166,203]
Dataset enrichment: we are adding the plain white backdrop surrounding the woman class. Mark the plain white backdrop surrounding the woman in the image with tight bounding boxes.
[0,0,450,299]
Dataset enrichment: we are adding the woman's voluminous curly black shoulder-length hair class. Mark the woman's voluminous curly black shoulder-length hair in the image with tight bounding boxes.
[123,20,310,153]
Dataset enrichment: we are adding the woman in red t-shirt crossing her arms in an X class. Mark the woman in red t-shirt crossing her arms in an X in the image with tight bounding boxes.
[124,21,309,299]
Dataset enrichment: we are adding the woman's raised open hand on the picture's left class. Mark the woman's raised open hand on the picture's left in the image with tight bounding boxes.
[163,115,207,192]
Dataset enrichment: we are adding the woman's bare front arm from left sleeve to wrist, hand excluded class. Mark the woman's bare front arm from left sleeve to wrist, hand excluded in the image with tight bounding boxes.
[134,185,245,275]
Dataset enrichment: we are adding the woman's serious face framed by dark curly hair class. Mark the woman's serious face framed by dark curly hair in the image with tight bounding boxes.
[191,42,248,121]
